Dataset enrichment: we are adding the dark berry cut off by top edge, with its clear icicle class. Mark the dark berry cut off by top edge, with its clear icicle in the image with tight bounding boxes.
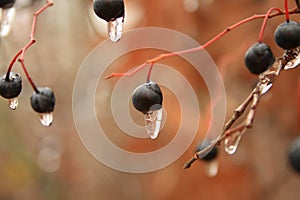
[93,0,125,42]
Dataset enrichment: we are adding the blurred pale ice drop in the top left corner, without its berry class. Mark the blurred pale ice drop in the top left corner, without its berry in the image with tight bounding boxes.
[0,7,16,37]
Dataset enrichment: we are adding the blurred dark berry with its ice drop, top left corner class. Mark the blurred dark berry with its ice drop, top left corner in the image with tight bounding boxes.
[0,0,16,37]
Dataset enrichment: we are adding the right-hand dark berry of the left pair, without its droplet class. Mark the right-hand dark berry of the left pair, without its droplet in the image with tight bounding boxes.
[30,87,55,113]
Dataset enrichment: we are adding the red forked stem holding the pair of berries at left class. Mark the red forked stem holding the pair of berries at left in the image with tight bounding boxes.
[5,0,53,92]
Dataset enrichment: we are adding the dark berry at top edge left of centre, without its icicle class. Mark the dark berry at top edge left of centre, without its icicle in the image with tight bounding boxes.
[93,0,125,22]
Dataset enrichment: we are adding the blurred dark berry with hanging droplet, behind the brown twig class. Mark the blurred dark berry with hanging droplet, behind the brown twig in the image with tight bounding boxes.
[196,140,219,177]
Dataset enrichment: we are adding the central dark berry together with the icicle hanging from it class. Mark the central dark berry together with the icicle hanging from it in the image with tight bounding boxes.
[132,81,163,139]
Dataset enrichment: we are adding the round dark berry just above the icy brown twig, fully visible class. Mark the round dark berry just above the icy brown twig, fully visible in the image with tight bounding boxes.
[245,42,275,74]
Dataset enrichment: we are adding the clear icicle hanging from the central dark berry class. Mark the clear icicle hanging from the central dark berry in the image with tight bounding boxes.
[144,109,162,139]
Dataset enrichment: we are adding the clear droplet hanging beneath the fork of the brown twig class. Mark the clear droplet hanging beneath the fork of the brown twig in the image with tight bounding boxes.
[224,129,246,155]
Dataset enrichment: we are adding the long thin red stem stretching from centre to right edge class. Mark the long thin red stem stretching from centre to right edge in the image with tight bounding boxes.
[105,8,300,79]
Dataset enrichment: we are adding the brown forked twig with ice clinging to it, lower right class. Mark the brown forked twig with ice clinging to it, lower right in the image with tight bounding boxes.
[184,49,300,169]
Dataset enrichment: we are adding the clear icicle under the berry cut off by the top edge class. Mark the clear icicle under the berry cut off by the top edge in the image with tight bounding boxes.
[107,17,124,42]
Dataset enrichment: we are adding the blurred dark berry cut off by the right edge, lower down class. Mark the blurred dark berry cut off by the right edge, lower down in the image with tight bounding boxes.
[288,137,300,173]
